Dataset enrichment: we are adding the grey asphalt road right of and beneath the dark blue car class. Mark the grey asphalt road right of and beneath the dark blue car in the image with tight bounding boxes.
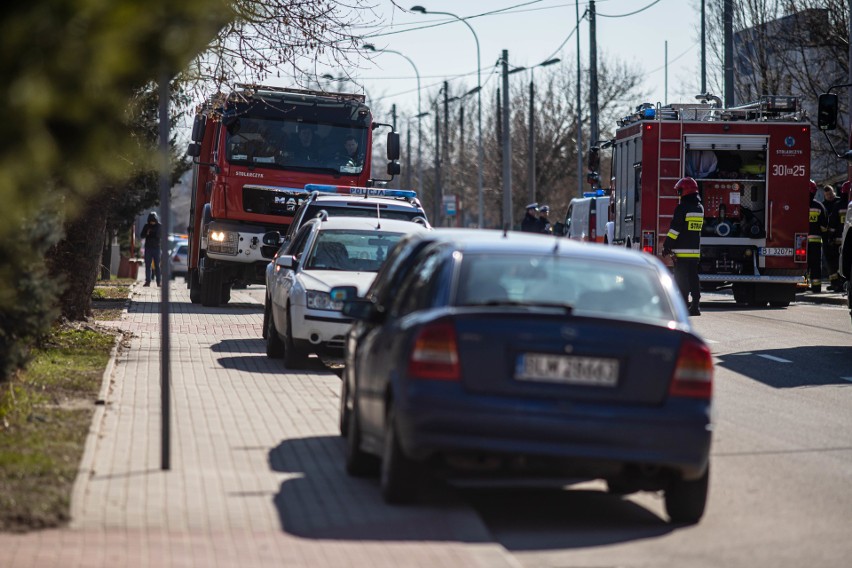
[241,288,852,568]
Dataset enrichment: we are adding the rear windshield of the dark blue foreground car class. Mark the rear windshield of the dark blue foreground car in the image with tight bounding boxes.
[454,254,675,322]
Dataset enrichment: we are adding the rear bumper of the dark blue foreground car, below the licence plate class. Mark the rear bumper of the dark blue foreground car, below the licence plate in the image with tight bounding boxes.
[395,385,712,478]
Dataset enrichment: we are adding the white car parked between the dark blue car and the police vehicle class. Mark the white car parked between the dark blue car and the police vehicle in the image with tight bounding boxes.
[264,214,428,369]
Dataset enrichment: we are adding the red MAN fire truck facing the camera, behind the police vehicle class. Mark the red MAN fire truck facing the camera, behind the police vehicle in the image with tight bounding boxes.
[186,85,399,306]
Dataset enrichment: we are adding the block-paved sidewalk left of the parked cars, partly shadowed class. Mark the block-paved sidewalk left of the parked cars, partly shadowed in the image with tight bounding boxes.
[0,281,517,568]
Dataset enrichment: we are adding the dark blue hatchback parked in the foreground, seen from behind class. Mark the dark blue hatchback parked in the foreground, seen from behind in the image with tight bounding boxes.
[331,229,713,523]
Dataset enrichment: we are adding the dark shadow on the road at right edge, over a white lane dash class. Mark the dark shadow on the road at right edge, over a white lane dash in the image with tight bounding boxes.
[717,345,852,389]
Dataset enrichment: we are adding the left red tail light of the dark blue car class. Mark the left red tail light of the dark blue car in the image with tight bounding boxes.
[408,320,461,381]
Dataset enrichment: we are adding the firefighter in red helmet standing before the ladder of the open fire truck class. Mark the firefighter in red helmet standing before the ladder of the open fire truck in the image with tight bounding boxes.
[663,177,704,316]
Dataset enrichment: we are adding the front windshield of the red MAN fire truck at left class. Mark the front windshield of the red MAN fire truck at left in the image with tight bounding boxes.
[225,117,367,175]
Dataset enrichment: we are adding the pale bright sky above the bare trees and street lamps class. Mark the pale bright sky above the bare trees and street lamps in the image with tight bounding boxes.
[306,0,700,117]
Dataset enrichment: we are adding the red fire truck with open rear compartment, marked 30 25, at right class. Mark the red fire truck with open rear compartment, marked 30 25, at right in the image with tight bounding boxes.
[613,94,811,307]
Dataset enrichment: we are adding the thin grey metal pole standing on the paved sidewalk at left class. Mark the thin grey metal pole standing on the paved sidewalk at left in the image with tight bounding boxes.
[159,72,171,471]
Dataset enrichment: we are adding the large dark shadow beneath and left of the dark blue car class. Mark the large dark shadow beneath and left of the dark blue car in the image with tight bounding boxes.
[269,436,678,550]
